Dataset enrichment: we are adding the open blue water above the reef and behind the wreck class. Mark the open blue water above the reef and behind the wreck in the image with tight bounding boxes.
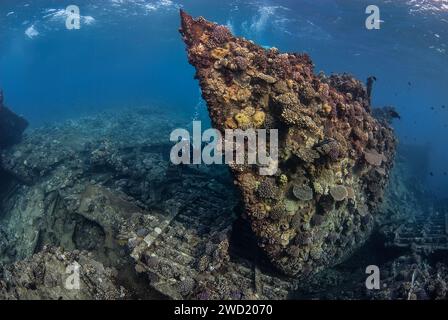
[0,0,448,197]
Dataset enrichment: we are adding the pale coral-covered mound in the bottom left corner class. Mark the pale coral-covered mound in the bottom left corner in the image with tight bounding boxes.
[0,247,128,300]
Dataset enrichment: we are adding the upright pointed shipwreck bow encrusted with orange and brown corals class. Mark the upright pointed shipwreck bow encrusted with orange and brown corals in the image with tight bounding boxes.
[180,12,396,275]
